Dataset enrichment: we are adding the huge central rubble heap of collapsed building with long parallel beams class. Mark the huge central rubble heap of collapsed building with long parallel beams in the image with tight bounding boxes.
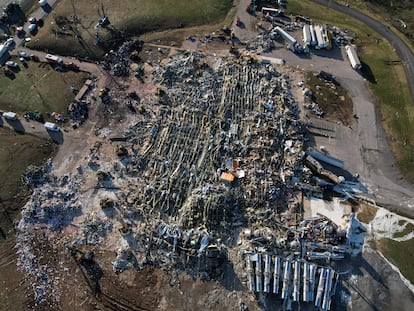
[85,52,310,276]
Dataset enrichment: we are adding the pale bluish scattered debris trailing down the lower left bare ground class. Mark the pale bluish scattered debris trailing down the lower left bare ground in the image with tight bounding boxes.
[16,160,82,308]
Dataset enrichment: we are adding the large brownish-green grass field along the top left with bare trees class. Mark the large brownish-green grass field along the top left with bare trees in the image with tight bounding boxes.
[29,0,233,58]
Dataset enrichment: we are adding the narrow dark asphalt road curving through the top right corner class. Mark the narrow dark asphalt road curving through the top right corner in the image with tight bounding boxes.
[312,0,414,99]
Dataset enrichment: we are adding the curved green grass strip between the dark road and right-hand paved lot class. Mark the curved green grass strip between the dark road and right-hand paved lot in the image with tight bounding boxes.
[286,0,414,182]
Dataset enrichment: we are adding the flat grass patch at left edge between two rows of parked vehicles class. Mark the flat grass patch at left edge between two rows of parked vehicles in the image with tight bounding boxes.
[0,59,87,114]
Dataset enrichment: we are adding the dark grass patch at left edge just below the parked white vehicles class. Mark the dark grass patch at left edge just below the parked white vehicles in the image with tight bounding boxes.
[0,127,54,203]
